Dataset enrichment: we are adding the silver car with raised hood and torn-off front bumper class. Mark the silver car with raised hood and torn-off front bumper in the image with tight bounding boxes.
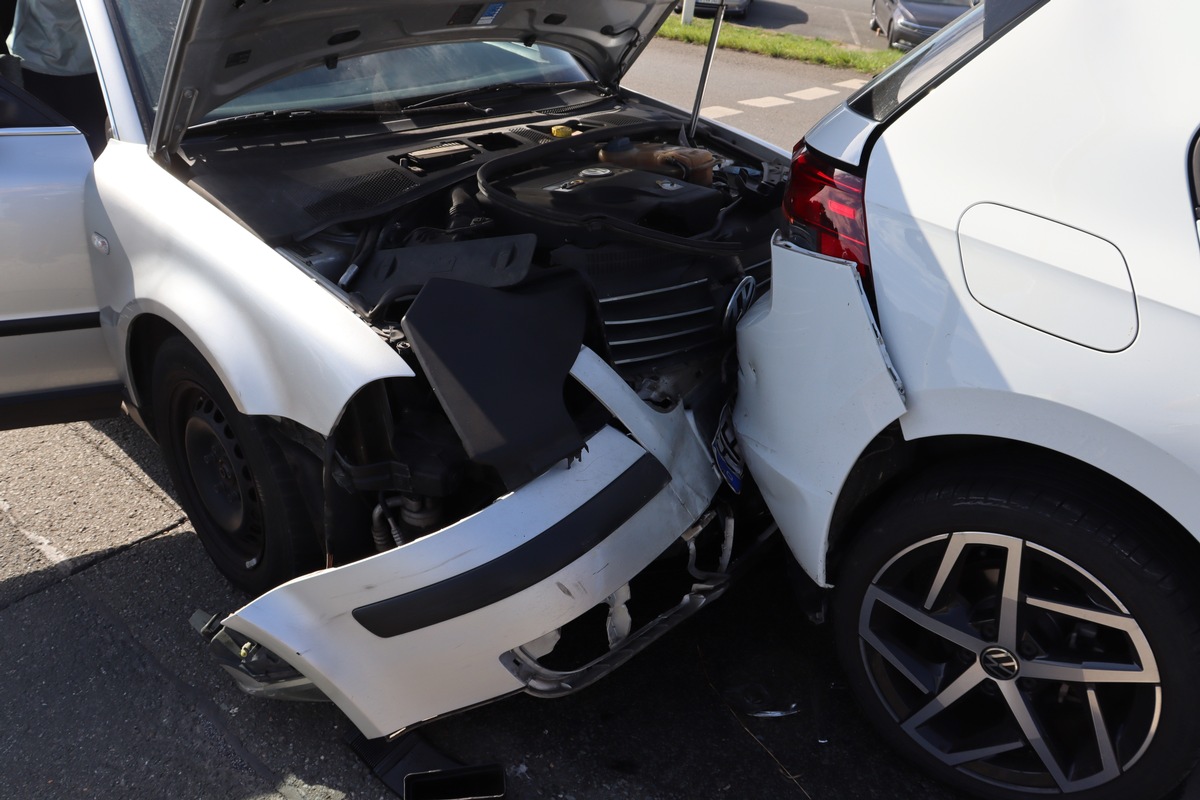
[0,0,787,738]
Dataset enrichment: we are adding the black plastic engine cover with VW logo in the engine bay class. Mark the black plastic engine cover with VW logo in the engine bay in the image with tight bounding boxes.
[497,164,725,235]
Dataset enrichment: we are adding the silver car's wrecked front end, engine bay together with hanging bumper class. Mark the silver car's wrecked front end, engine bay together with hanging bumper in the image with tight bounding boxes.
[179,25,786,738]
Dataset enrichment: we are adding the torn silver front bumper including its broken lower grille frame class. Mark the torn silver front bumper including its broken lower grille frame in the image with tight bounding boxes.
[206,335,760,738]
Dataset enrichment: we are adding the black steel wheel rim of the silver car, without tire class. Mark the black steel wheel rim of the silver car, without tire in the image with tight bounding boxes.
[175,386,266,570]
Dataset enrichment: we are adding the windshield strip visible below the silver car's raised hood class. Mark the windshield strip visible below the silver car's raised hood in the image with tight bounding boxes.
[204,42,590,121]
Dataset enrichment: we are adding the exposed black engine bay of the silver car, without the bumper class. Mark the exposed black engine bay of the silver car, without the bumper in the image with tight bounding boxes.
[186,95,787,670]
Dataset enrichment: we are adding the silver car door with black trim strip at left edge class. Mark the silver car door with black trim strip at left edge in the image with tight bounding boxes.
[0,79,121,429]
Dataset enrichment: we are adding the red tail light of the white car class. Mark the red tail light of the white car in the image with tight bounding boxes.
[784,140,871,278]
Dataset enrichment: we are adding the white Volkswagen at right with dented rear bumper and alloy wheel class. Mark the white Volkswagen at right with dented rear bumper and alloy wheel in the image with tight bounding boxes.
[734,0,1200,800]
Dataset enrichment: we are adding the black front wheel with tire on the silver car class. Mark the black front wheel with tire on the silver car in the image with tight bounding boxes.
[152,337,320,595]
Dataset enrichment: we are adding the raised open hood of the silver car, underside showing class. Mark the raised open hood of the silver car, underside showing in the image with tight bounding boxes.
[150,0,676,152]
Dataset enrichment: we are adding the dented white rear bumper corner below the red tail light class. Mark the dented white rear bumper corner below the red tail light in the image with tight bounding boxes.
[733,234,905,584]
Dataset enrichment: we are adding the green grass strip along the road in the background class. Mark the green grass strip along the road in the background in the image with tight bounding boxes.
[658,14,904,76]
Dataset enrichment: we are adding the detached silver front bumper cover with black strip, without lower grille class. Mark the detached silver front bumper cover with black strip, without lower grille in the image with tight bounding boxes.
[204,348,720,738]
